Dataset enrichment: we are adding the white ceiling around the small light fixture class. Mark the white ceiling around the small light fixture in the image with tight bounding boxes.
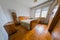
[16,0,48,7]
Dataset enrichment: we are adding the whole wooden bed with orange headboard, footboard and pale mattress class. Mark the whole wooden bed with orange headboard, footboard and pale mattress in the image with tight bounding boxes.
[18,16,38,30]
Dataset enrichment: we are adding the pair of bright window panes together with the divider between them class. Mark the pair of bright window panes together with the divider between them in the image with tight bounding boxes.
[35,7,49,18]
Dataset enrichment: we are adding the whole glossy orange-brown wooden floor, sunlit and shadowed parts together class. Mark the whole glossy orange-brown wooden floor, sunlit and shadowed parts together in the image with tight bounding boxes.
[10,24,52,40]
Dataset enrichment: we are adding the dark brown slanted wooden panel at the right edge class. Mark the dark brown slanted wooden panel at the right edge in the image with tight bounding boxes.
[49,5,60,33]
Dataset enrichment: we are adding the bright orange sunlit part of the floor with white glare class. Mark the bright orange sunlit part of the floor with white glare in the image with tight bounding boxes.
[23,25,52,40]
